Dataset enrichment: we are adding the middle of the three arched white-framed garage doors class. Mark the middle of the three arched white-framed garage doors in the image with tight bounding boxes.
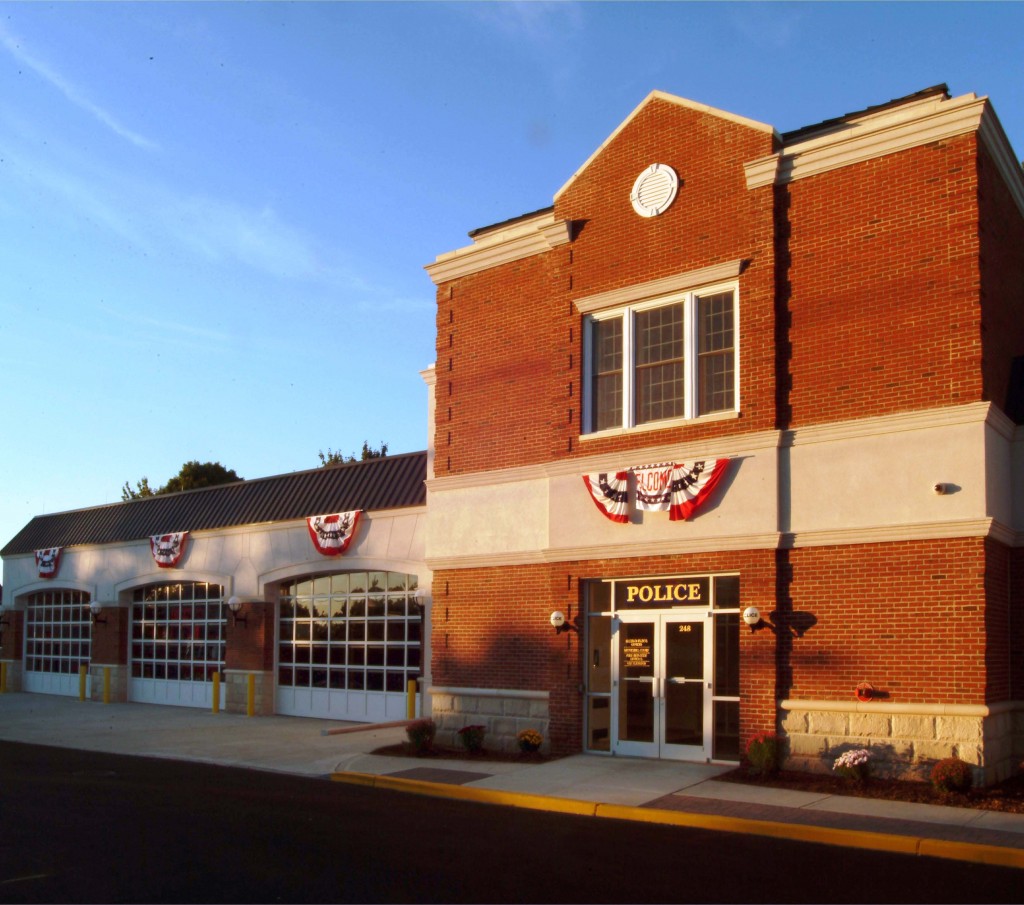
[128,581,225,707]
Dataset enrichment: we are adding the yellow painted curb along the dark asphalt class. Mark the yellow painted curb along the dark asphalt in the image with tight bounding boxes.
[331,773,1024,869]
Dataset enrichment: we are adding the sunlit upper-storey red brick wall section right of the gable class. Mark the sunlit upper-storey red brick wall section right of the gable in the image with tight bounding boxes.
[786,135,982,426]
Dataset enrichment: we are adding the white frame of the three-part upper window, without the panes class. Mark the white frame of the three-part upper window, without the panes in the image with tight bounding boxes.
[582,281,740,439]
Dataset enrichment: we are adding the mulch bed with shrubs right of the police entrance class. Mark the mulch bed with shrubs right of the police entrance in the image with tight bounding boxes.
[716,767,1024,814]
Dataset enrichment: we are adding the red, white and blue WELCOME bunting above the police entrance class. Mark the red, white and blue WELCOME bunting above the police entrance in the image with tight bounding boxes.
[583,459,729,524]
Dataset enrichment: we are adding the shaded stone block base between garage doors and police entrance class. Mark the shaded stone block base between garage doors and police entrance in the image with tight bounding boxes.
[430,687,551,753]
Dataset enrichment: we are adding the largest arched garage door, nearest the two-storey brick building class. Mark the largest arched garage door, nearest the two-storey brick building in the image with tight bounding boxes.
[276,571,422,722]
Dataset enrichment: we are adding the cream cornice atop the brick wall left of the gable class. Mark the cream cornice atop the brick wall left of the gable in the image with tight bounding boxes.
[424,211,571,286]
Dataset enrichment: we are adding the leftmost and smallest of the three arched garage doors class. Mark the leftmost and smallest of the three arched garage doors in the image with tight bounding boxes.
[25,590,92,696]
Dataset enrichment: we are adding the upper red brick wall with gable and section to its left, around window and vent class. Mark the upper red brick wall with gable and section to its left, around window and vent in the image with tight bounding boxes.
[435,101,775,477]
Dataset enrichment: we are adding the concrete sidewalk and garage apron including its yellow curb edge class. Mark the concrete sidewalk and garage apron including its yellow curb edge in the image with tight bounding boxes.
[0,694,1024,867]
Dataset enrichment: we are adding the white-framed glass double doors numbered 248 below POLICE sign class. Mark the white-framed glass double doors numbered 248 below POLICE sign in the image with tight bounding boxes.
[612,611,712,761]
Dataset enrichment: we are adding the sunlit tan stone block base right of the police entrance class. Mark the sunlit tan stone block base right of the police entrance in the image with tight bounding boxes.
[781,700,1024,786]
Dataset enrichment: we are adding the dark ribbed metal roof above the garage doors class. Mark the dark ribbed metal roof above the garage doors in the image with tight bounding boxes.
[0,451,427,556]
